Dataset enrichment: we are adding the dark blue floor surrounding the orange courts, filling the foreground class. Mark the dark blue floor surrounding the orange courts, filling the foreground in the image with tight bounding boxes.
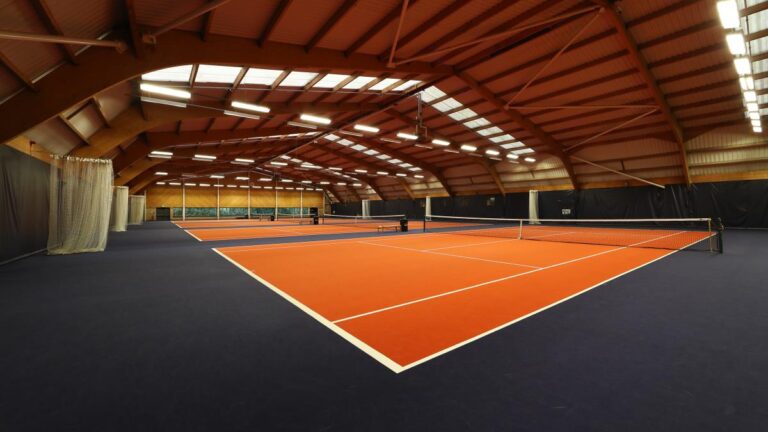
[0,222,768,432]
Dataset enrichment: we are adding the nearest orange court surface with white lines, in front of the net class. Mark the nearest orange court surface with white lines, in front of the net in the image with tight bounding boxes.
[215,227,707,372]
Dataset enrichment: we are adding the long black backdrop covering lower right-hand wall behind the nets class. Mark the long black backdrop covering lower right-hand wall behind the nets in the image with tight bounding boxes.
[333,180,768,228]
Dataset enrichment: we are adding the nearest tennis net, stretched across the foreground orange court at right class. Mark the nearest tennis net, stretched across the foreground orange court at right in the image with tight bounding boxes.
[424,215,723,253]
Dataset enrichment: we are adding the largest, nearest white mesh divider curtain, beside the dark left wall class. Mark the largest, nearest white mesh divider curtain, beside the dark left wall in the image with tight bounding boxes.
[48,156,114,255]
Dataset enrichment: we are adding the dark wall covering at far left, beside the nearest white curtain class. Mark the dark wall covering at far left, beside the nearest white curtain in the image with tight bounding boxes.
[0,145,50,263]
